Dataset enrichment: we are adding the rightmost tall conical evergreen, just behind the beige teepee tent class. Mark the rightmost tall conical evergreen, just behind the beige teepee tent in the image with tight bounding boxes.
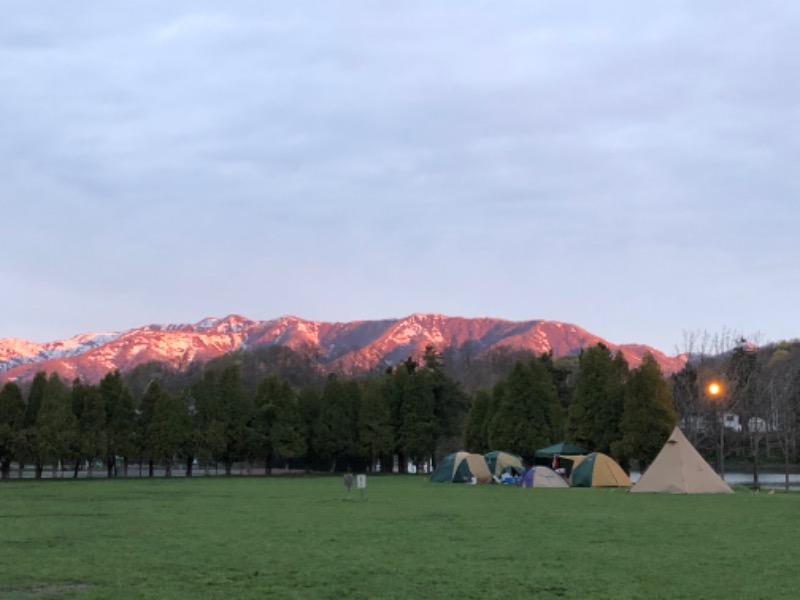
[612,353,678,471]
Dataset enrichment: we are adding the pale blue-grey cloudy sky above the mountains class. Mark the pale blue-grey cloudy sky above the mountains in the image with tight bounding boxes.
[0,0,800,354]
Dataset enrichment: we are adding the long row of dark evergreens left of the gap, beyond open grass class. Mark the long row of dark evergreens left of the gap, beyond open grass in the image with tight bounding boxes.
[0,348,468,478]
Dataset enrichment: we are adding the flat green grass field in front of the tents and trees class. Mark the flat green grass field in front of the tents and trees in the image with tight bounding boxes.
[0,476,800,600]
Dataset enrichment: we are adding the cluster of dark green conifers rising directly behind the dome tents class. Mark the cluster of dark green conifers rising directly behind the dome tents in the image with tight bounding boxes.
[465,344,678,468]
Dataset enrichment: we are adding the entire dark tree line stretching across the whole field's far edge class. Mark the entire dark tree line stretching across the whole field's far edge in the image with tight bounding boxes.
[0,344,800,478]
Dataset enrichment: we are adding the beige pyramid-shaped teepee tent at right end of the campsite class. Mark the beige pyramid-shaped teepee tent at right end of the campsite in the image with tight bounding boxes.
[631,427,733,494]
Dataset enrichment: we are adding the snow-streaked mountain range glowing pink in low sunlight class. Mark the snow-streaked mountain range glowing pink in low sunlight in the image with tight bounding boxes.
[0,314,685,383]
